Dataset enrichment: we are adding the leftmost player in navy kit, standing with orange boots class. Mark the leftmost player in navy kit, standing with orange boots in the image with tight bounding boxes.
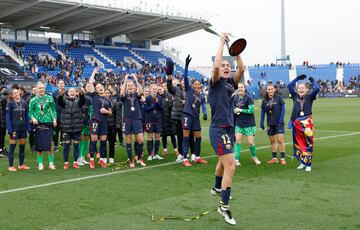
[5,89,30,172]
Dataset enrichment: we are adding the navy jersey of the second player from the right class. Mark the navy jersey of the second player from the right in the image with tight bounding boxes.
[261,94,285,126]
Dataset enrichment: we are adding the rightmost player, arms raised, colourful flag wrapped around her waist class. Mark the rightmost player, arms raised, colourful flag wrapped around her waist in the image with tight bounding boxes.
[288,75,320,172]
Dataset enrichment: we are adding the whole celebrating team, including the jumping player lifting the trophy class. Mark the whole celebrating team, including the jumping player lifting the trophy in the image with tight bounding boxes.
[2,33,319,224]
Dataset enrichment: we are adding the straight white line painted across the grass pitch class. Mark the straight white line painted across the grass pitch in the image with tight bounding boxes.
[0,132,360,194]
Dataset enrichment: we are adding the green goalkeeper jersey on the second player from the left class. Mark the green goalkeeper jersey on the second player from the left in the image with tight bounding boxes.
[29,94,57,124]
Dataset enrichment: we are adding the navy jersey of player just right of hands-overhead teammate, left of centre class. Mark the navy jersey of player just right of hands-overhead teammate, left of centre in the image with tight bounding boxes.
[144,95,163,123]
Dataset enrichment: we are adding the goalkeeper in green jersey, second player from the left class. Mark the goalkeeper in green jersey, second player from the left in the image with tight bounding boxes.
[29,82,57,170]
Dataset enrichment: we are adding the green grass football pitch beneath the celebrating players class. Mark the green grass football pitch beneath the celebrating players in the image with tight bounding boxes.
[0,98,360,229]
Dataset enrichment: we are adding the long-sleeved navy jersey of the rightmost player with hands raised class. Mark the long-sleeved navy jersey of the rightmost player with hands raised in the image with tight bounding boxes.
[288,79,320,121]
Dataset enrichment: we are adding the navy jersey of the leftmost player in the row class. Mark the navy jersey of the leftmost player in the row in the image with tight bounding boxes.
[5,100,29,133]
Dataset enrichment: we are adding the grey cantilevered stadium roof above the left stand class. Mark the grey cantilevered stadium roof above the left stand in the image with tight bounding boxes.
[0,0,210,40]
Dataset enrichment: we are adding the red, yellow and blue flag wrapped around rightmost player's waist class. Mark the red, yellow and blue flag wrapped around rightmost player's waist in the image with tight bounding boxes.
[293,116,314,166]
